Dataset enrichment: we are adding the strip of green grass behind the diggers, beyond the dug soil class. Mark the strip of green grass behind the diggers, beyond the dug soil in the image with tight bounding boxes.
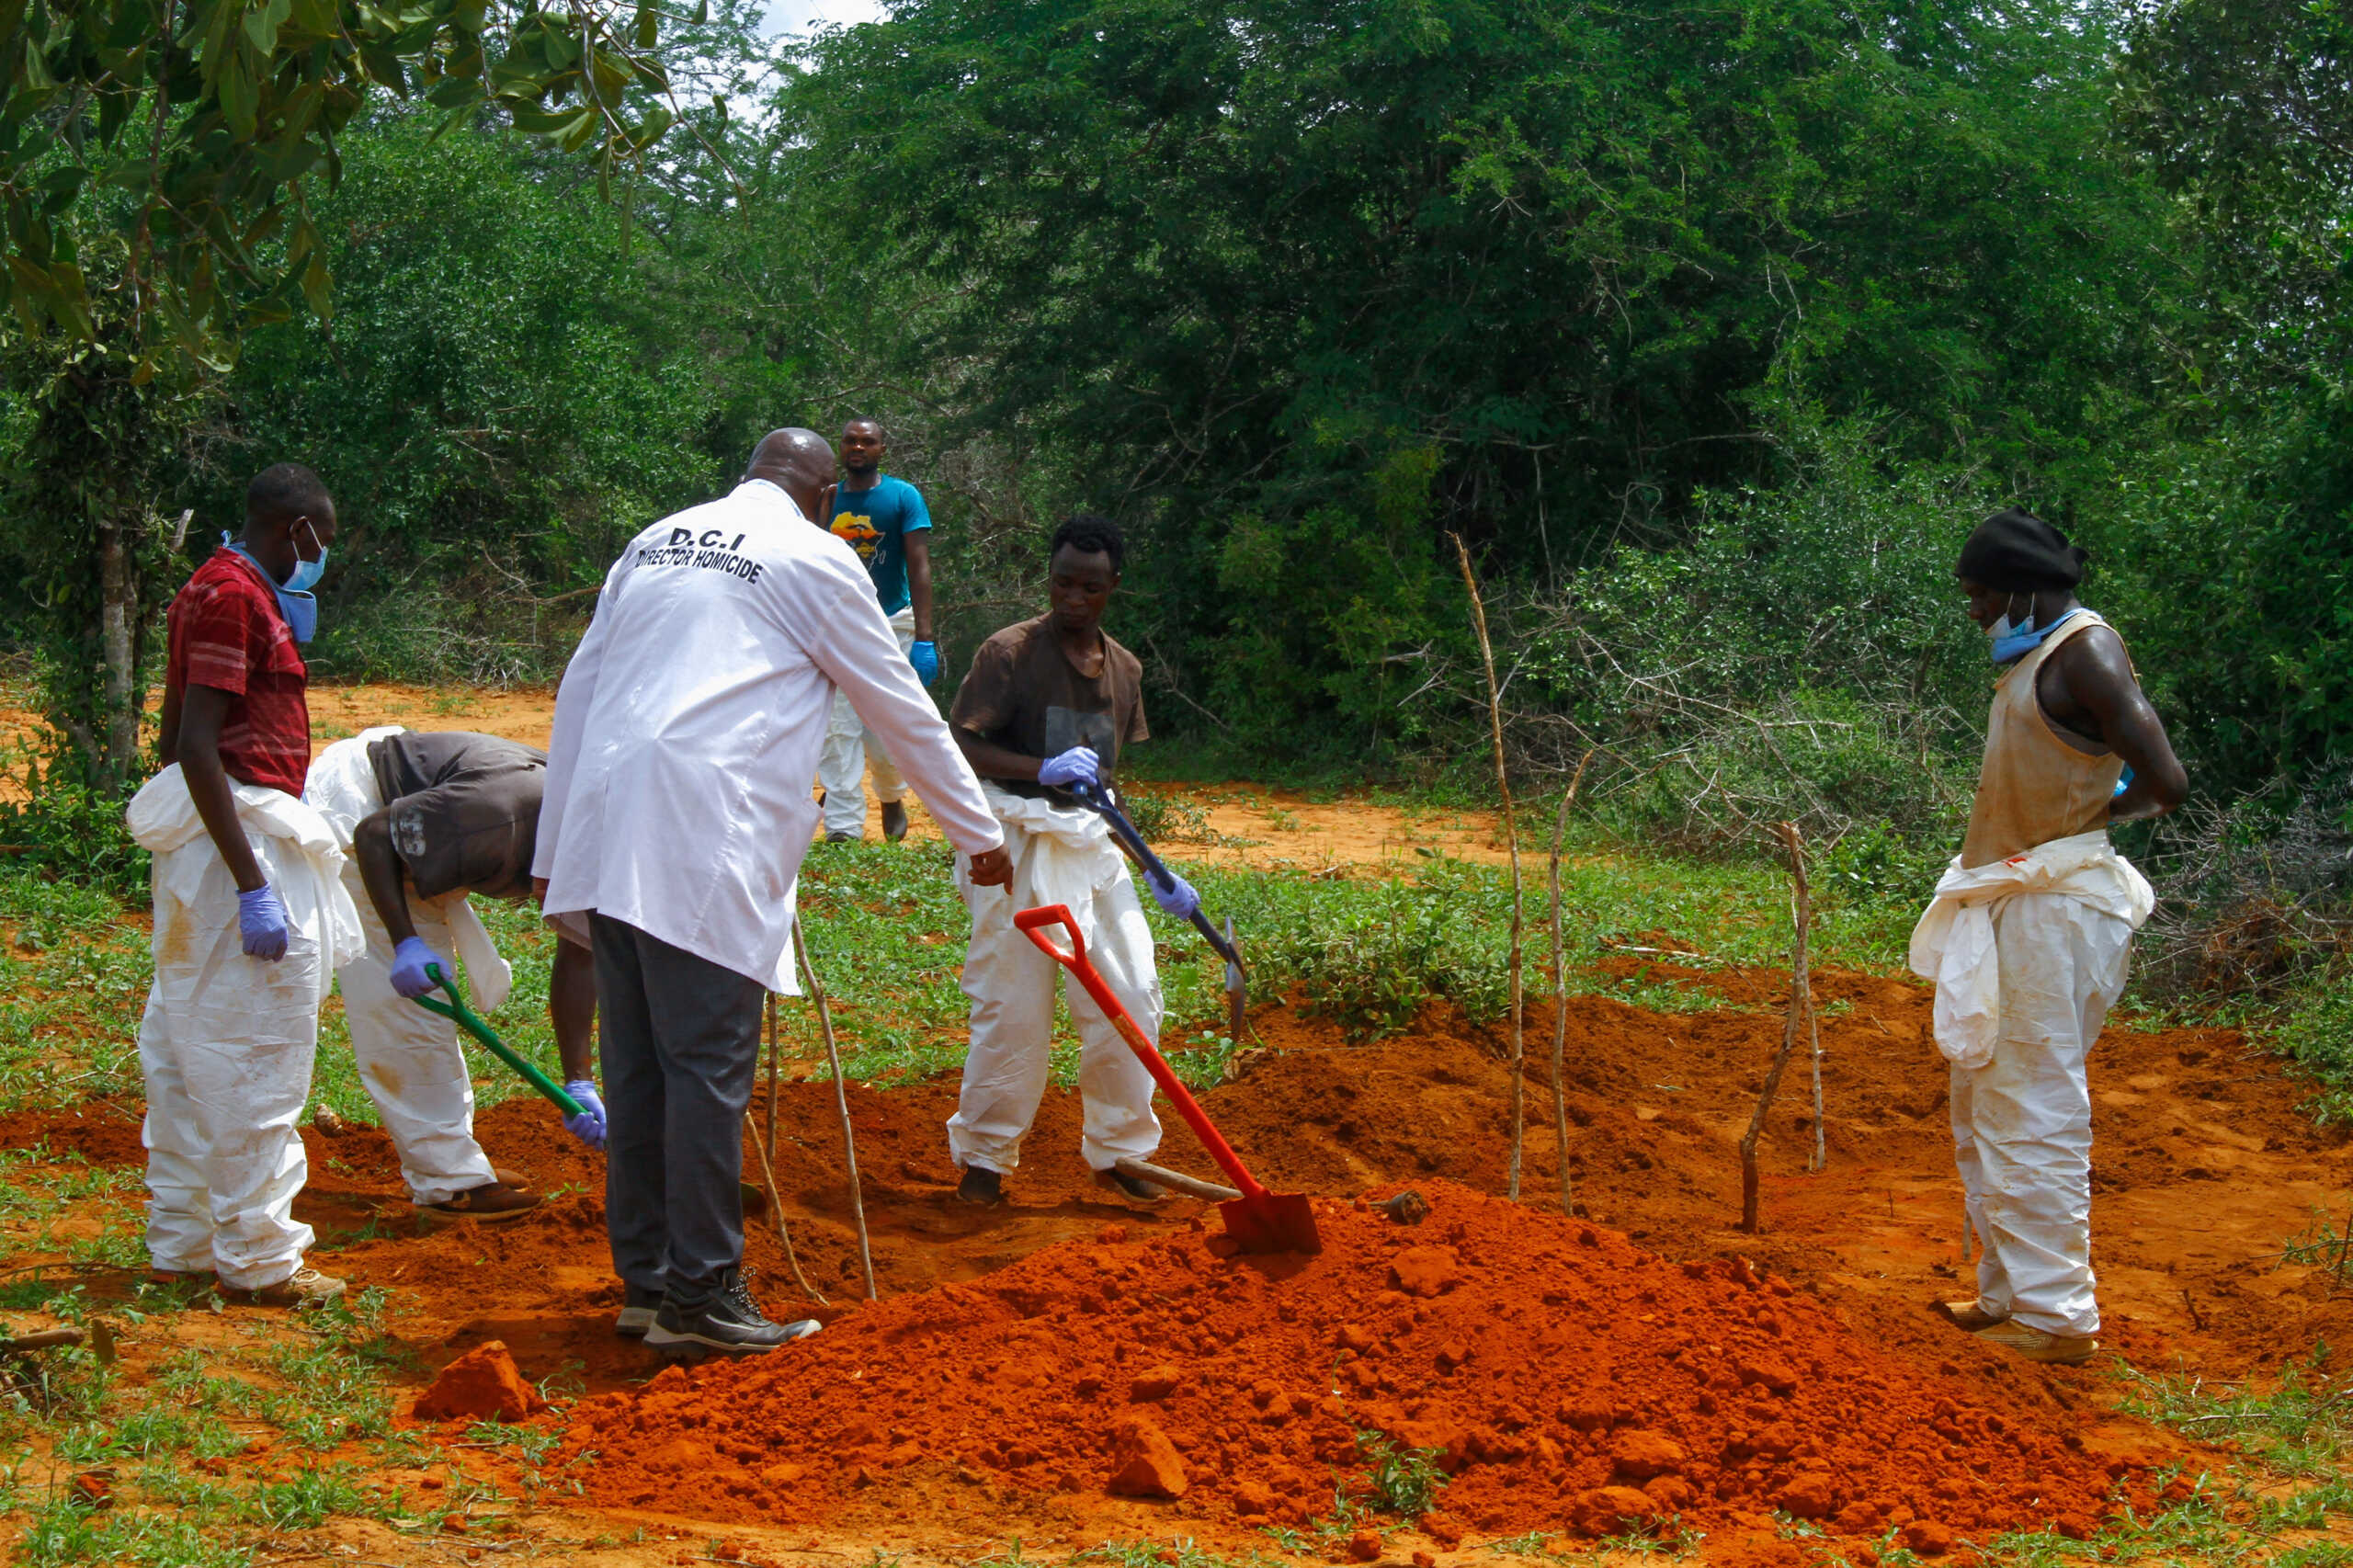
[0,798,1920,1123]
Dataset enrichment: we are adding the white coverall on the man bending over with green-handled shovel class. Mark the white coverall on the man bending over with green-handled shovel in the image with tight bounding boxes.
[303,725,516,1206]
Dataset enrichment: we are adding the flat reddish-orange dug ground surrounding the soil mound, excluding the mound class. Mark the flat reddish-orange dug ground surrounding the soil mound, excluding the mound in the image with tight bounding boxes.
[0,968,2353,1561]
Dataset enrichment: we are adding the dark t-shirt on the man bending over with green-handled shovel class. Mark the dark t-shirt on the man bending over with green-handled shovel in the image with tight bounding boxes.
[367,730,548,900]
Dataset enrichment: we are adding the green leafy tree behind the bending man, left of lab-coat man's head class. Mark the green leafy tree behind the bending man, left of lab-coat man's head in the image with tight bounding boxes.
[229,116,720,605]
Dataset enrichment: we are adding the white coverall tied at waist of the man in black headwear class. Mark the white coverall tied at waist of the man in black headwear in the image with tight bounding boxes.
[1911,834,2155,1340]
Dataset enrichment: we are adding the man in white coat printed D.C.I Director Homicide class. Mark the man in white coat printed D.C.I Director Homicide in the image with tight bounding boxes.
[532,431,1012,1354]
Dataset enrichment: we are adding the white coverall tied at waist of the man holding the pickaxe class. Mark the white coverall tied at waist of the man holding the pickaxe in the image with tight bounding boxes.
[949,779,1160,1173]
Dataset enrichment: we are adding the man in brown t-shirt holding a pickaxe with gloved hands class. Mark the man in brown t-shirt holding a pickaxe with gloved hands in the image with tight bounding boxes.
[949,513,1200,1206]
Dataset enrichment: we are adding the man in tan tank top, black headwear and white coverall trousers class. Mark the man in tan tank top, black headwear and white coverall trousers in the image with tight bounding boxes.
[1911,511,2188,1363]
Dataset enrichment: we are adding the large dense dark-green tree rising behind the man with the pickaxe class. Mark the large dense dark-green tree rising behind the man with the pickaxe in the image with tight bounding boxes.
[786,0,2172,746]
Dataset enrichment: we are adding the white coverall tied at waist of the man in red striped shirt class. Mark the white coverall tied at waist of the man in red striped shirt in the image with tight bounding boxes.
[127,763,360,1290]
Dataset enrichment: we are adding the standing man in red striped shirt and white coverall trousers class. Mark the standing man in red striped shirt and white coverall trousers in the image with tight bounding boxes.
[130,464,358,1307]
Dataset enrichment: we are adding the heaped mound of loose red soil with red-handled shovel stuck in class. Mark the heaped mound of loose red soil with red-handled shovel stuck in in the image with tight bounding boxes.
[572,1182,2139,1540]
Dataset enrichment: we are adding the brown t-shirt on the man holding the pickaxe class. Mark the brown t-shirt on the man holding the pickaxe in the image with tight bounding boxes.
[949,615,1151,796]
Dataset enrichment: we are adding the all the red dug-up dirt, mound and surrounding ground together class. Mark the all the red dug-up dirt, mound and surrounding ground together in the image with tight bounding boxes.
[0,965,2353,1561]
